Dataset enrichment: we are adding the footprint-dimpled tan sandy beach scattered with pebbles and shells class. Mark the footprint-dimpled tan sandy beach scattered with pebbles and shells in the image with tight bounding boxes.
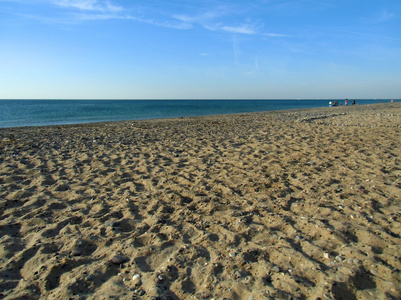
[0,103,401,299]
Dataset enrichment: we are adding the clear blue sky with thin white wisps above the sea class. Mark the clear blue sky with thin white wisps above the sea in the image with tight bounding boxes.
[0,0,401,99]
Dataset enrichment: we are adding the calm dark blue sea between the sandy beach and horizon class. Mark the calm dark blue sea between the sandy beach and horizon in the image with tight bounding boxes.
[0,100,390,128]
